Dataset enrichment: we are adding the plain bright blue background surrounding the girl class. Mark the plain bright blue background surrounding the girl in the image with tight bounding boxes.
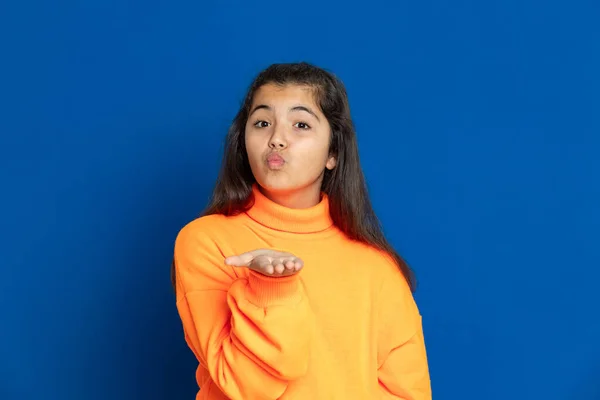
[0,0,600,400]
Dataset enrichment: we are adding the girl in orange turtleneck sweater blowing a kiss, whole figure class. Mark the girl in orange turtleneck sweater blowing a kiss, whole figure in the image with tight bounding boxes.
[172,63,431,400]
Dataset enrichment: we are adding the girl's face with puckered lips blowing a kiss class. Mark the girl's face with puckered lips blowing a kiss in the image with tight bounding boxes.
[245,84,336,208]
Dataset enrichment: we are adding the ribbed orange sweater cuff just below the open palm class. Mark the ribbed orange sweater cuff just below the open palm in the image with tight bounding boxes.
[248,270,301,307]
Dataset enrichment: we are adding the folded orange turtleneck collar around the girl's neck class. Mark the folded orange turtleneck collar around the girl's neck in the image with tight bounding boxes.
[246,184,333,233]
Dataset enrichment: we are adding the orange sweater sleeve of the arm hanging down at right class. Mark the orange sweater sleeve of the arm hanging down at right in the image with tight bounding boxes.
[378,264,431,400]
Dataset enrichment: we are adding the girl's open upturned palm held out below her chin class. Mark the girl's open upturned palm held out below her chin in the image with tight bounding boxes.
[225,249,304,276]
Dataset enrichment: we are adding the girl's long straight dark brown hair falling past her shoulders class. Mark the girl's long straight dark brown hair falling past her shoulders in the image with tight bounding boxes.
[171,62,416,291]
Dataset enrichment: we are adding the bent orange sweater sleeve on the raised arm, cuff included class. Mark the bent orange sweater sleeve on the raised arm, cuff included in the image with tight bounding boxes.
[175,222,312,400]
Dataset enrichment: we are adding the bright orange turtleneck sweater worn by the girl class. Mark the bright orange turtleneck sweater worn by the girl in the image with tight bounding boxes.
[175,187,431,400]
